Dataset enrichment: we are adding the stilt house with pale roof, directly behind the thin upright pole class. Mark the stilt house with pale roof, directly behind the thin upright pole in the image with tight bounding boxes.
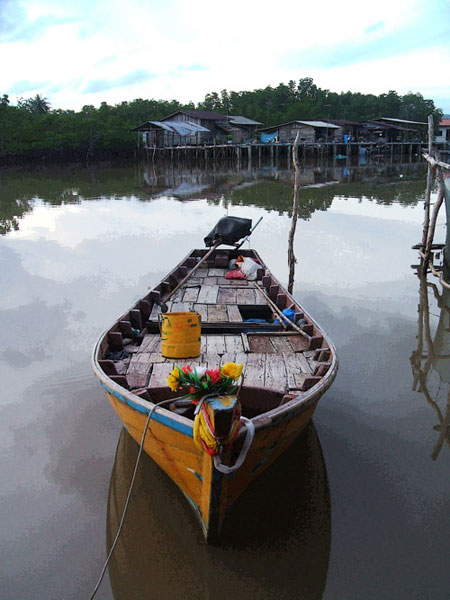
[259,121,342,144]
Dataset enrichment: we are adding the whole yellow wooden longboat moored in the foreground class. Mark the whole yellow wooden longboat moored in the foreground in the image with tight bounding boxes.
[93,218,338,541]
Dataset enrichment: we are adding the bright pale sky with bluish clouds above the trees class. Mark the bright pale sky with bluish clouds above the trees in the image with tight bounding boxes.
[0,0,450,113]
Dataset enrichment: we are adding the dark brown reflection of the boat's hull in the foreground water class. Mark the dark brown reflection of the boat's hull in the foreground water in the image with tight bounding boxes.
[107,423,331,600]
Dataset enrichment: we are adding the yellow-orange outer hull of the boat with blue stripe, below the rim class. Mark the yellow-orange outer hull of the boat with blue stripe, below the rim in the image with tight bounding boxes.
[106,389,319,541]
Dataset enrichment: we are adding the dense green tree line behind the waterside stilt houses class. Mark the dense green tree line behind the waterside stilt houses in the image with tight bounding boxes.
[0,77,442,163]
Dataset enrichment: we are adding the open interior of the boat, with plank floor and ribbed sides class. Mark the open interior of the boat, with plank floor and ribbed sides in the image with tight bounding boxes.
[97,249,333,418]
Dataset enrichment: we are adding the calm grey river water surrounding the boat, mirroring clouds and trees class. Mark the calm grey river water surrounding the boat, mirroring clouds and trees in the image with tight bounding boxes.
[0,164,450,600]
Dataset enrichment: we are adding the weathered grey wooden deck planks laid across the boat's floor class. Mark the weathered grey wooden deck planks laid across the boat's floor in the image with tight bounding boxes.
[116,246,330,392]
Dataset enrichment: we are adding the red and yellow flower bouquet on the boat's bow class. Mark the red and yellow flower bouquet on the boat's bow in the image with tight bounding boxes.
[167,362,244,404]
